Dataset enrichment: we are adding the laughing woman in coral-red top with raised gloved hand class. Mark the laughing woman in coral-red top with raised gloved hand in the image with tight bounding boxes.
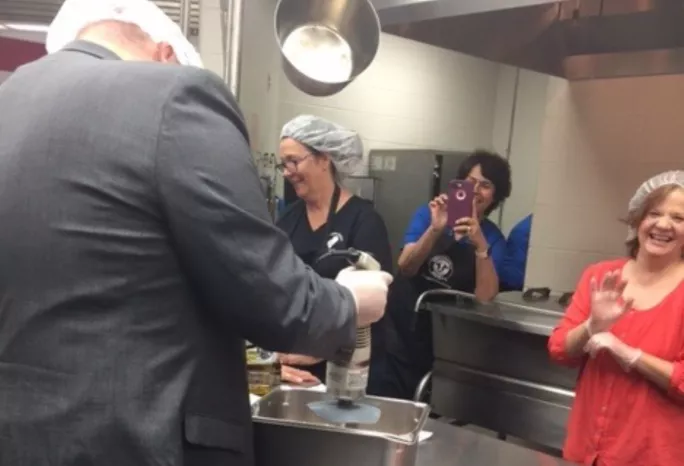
[549,171,684,466]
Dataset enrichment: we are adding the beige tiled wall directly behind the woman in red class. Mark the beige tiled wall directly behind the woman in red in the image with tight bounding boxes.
[526,76,684,291]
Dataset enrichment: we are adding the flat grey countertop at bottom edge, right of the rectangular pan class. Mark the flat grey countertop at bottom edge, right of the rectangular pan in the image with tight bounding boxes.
[416,420,574,466]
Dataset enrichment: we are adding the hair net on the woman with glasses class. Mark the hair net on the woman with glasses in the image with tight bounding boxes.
[280,115,363,176]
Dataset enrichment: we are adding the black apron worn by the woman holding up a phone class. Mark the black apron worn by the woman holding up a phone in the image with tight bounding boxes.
[378,234,476,399]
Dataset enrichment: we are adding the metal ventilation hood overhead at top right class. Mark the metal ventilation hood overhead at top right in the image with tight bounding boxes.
[373,0,684,80]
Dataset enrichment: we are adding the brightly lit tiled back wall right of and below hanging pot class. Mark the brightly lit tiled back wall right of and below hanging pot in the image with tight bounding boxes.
[278,34,498,175]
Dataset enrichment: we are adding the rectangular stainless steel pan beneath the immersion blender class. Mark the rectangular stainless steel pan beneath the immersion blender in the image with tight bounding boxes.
[252,388,430,466]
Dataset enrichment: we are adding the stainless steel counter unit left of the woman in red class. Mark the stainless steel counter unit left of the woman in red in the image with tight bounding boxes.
[420,292,577,450]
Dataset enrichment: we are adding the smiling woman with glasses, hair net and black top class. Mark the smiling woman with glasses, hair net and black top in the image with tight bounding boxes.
[277,116,392,391]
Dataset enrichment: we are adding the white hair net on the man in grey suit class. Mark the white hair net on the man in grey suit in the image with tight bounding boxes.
[45,0,203,68]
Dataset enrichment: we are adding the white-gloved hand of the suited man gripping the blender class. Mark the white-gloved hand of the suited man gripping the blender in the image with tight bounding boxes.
[335,267,393,327]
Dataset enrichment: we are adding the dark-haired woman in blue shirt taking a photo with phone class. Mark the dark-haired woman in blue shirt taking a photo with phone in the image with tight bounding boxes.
[378,151,511,399]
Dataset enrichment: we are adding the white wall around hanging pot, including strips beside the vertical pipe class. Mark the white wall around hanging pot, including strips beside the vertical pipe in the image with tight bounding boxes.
[200,0,498,177]
